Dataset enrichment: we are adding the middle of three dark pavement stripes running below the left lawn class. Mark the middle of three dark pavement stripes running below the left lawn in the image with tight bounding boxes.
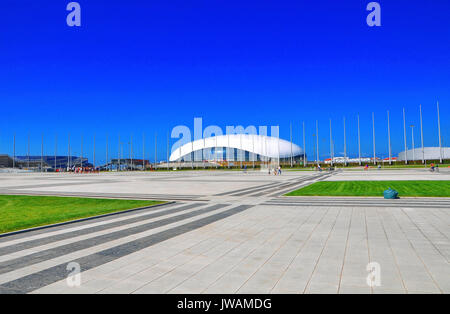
[0,204,229,274]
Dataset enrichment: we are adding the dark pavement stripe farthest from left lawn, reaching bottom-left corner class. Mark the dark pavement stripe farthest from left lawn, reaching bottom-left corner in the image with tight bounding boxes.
[0,205,253,293]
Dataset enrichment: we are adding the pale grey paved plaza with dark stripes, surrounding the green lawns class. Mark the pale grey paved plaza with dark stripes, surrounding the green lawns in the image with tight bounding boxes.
[0,169,450,293]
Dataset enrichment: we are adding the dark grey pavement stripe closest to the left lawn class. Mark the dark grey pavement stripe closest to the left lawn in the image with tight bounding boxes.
[0,203,204,256]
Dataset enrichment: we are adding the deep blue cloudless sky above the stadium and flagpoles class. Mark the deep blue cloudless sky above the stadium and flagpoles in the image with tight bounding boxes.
[0,0,450,162]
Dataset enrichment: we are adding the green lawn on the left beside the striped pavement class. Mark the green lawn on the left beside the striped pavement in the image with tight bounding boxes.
[0,195,163,233]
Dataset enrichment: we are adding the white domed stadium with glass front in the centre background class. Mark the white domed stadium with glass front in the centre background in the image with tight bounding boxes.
[169,134,306,162]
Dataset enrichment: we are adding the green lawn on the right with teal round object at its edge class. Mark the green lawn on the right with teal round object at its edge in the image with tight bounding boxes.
[286,181,450,197]
